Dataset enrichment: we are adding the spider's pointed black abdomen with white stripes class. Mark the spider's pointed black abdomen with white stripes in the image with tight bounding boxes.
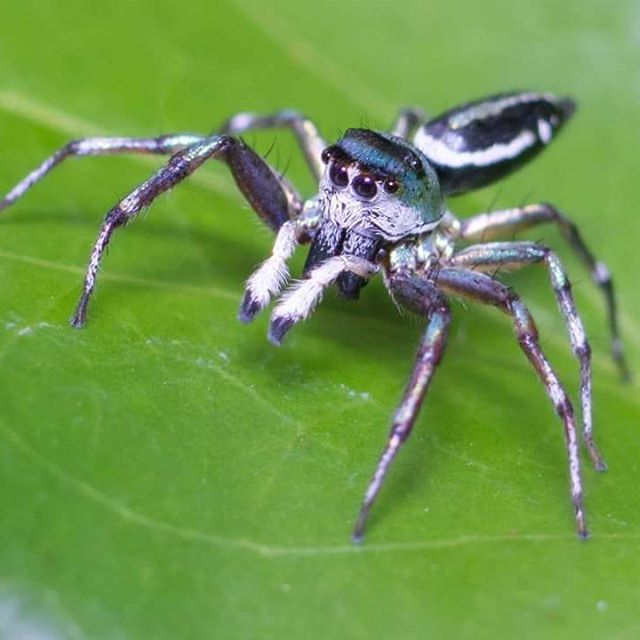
[413,93,575,194]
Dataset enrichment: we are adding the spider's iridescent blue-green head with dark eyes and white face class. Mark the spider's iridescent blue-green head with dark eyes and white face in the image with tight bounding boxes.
[305,129,444,298]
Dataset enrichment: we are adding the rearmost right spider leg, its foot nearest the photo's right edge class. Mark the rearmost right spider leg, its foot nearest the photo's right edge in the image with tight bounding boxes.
[460,203,631,381]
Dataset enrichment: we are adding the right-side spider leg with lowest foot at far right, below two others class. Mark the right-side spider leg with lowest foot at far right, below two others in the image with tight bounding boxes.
[436,268,588,538]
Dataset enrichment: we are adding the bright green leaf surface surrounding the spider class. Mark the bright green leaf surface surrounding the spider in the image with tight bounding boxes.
[0,0,640,639]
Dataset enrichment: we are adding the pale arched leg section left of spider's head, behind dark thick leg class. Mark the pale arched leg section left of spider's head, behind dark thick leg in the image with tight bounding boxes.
[218,110,327,180]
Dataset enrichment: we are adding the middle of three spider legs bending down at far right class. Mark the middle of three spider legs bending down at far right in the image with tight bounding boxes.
[448,242,607,471]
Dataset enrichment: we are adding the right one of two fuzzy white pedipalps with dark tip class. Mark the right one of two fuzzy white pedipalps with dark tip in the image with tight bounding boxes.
[269,254,379,345]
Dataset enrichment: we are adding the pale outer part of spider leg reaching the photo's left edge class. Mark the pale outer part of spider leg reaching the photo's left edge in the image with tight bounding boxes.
[0,133,204,211]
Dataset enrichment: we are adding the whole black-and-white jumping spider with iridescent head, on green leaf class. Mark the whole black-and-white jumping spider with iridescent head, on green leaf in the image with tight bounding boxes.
[0,92,628,541]
